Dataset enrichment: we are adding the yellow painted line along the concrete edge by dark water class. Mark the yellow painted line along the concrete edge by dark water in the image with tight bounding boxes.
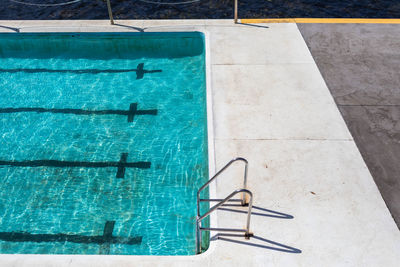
[240,18,400,24]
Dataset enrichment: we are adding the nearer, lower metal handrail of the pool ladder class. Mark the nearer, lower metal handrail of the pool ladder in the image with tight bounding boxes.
[196,188,253,254]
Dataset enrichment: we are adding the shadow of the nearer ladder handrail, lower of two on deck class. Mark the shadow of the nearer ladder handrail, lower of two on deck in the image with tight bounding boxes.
[210,233,302,254]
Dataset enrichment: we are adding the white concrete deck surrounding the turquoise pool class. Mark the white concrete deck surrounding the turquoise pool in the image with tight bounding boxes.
[0,20,400,267]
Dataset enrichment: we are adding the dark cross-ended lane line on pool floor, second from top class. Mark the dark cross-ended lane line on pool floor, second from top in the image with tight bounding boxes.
[0,103,158,122]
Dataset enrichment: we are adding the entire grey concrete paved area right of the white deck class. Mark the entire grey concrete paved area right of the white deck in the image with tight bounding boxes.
[298,24,400,227]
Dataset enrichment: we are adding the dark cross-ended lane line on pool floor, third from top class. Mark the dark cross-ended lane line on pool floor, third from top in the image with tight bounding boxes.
[0,153,151,178]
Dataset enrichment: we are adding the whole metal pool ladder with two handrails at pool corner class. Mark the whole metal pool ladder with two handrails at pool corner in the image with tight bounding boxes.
[196,158,253,254]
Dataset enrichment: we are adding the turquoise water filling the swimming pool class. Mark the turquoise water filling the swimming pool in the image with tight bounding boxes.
[0,32,208,255]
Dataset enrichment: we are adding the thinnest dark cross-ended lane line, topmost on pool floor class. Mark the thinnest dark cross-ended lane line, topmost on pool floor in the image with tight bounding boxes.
[0,63,162,80]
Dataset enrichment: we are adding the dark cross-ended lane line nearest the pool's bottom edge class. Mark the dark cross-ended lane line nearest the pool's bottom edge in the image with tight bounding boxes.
[0,221,143,251]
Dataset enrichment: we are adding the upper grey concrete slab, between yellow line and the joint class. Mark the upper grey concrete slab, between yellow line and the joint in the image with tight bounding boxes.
[299,24,400,105]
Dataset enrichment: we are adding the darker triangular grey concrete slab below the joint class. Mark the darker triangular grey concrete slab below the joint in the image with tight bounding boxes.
[340,106,400,222]
